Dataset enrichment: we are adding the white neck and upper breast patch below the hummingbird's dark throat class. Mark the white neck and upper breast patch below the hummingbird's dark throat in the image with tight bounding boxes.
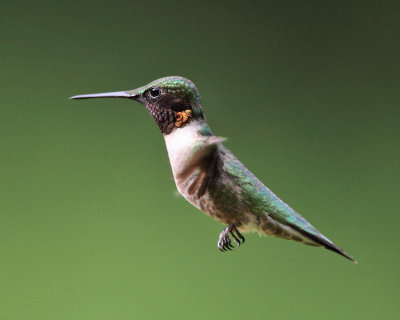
[164,120,213,177]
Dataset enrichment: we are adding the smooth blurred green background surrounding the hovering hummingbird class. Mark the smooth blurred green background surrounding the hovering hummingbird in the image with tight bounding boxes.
[0,1,400,320]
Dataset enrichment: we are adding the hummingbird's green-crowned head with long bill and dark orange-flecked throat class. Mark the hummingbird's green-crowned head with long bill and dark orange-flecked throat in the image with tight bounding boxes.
[70,76,205,135]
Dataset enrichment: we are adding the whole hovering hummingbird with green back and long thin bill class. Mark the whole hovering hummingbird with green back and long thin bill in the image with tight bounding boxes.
[70,76,356,263]
